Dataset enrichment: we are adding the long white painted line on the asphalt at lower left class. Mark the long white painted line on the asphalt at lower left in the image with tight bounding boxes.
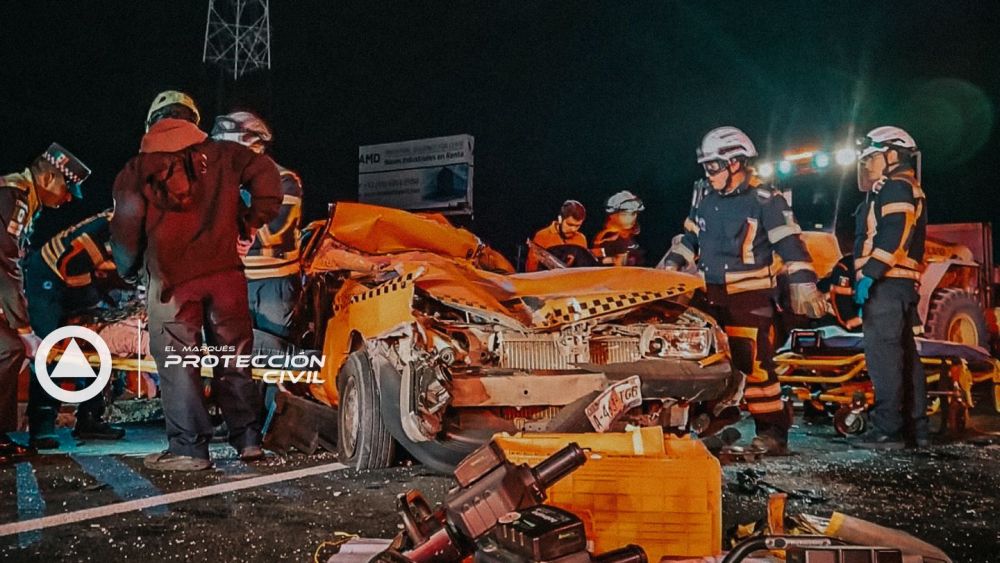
[0,463,347,537]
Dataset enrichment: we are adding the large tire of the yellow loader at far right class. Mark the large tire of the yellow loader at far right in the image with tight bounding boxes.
[924,288,989,348]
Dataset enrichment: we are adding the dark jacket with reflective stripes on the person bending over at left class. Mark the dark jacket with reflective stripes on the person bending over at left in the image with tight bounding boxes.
[41,209,115,288]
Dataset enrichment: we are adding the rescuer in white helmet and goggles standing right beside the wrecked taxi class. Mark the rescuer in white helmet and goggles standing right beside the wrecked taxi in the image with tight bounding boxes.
[664,127,827,455]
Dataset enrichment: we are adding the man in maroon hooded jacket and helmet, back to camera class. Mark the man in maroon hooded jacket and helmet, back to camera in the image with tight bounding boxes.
[111,91,281,471]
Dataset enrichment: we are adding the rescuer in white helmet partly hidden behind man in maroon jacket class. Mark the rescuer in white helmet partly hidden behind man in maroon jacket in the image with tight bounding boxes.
[212,111,302,339]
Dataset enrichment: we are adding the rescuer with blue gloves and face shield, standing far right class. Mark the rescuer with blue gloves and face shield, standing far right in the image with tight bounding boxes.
[854,126,930,449]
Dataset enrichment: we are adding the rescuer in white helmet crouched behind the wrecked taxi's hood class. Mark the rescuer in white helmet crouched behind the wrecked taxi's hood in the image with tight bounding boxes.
[591,190,646,266]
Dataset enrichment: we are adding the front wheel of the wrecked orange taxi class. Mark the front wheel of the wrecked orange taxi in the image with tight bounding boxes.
[337,351,396,469]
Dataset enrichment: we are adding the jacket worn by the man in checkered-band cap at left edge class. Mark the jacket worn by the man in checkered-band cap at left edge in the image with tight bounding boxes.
[0,169,41,333]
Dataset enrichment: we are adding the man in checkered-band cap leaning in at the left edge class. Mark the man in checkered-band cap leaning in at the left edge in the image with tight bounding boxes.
[0,143,90,461]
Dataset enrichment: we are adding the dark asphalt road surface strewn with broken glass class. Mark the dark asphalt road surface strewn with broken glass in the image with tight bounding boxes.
[0,415,1000,563]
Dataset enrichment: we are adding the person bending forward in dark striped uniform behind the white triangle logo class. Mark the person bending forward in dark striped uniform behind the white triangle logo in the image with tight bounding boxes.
[24,209,125,450]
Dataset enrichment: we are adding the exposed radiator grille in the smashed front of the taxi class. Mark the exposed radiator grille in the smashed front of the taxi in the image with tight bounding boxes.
[500,337,642,370]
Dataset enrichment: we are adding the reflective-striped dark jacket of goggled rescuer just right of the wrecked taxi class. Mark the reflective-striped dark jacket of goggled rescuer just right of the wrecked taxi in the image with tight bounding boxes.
[667,177,816,293]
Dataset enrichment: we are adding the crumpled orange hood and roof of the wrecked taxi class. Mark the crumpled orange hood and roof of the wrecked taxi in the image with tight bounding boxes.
[309,203,704,331]
